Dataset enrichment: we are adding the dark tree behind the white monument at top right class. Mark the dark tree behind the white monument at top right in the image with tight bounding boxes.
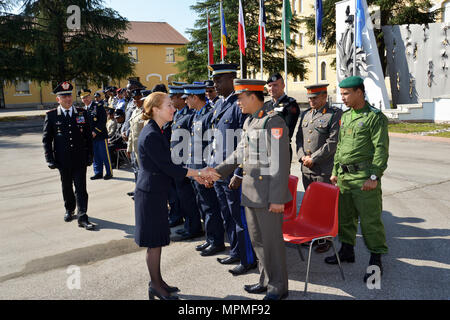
[302,0,440,71]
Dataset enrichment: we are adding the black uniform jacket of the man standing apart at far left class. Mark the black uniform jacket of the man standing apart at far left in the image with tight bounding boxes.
[42,108,93,168]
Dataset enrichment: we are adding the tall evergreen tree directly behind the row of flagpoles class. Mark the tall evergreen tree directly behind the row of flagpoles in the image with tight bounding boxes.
[177,0,307,82]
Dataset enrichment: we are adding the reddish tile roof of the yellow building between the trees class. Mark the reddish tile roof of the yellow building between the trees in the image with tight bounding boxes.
[124,21,189,44]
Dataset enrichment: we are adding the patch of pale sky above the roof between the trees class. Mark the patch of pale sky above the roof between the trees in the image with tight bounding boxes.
[104,0,197,39]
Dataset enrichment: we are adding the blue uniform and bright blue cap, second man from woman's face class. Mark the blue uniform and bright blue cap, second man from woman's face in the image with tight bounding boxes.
[184,85,225,256]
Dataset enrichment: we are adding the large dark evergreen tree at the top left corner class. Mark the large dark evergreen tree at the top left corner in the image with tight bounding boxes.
[0,0,133,86]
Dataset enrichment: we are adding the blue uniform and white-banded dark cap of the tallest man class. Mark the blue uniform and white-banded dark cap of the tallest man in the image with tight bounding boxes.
[209,65,255,267]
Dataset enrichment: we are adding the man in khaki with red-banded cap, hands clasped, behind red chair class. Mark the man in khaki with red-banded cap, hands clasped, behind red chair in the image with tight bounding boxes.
[296,84,342,253]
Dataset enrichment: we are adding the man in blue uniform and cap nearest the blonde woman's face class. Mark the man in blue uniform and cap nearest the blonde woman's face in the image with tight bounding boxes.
[169,82,204,241]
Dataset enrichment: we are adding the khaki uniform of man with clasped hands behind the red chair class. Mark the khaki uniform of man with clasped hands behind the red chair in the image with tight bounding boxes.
[296,103,342,190]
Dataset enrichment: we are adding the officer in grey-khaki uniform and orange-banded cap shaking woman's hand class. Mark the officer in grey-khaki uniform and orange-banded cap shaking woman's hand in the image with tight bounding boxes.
[205,79,292,300]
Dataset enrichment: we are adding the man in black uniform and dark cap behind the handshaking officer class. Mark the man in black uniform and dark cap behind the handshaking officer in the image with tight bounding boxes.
[264,73,300,161]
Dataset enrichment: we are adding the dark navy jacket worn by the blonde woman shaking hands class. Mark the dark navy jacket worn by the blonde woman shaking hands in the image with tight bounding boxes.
[136,120,187,193]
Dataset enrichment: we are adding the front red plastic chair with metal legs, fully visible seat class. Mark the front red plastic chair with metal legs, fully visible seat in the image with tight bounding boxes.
[283,182,345,294]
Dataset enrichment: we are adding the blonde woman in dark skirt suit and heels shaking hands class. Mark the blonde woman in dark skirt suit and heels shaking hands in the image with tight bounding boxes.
[134,92,218,299]
